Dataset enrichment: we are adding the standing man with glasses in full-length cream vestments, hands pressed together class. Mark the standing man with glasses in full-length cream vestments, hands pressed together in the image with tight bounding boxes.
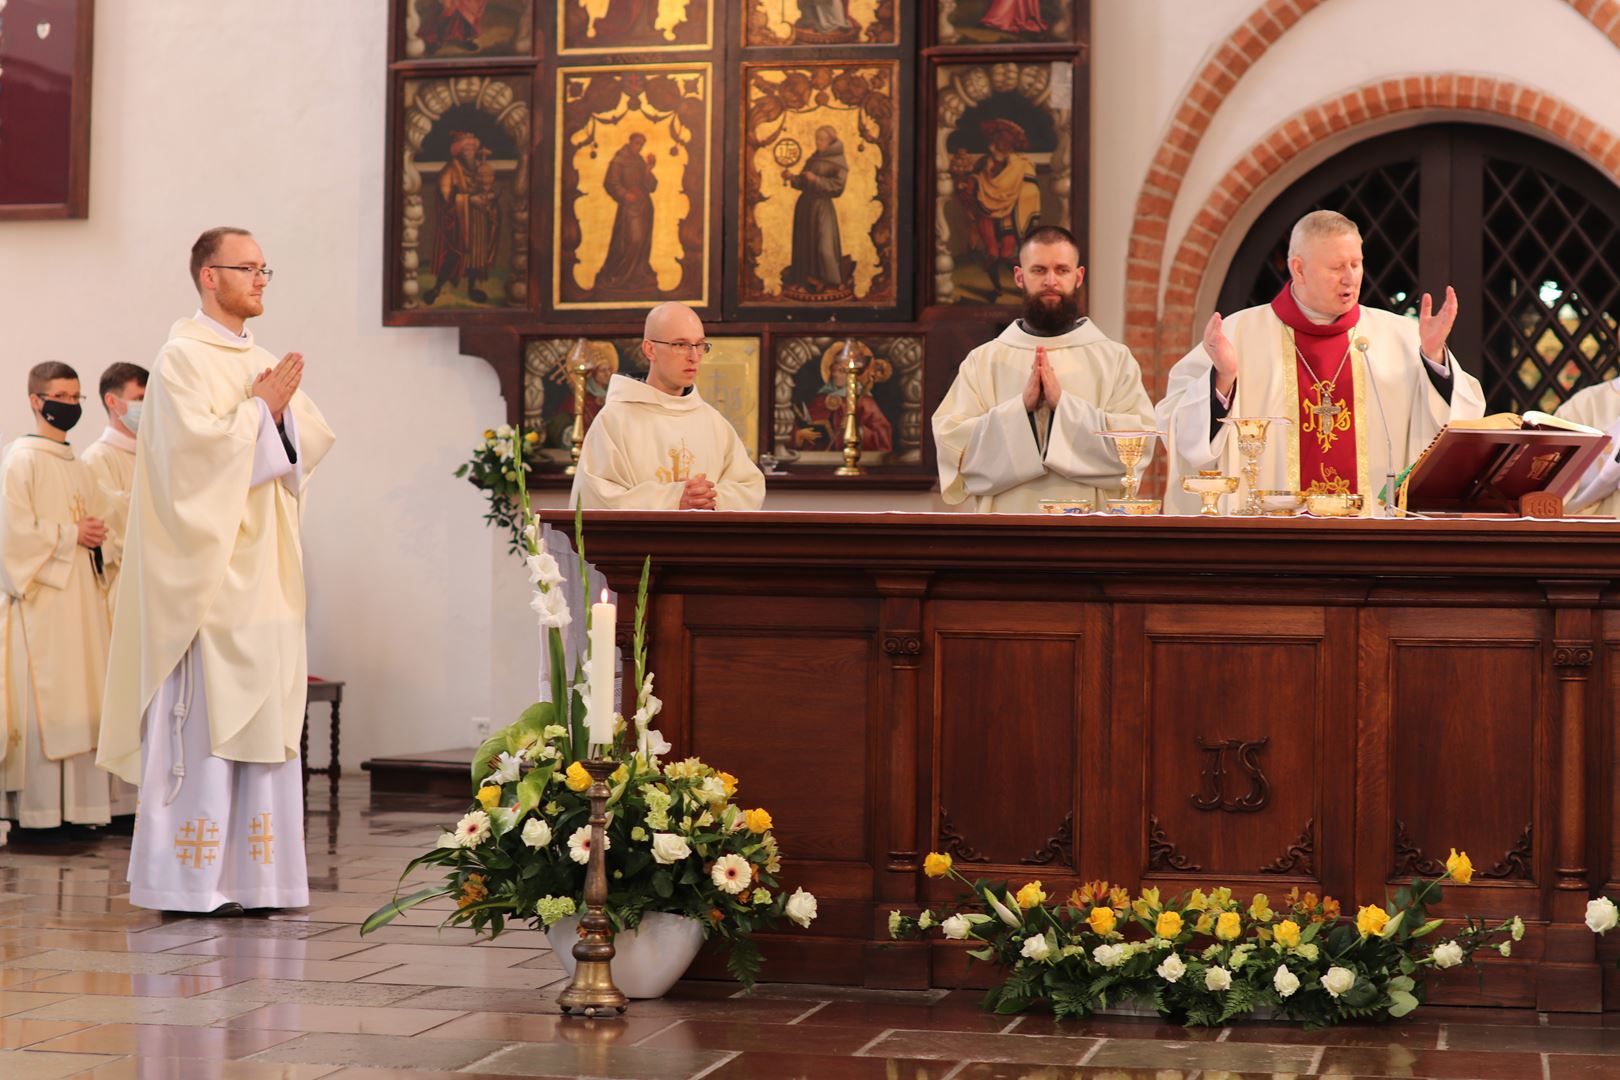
[97,228,332,915]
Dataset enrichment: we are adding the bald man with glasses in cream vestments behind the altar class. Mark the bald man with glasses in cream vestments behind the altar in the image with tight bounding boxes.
[569,303,765,510]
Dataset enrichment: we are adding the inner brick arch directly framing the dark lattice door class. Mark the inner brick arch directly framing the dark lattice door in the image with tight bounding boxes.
[1155,74,1620,362]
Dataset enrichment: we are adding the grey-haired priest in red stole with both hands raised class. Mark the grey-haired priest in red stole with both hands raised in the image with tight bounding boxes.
[1157,210,1486,513]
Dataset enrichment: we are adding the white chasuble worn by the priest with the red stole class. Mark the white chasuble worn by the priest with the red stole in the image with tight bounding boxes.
[1157,304,1486,515]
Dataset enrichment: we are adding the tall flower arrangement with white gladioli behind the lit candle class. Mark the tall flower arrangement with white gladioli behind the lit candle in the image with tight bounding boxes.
[361,432,816,986]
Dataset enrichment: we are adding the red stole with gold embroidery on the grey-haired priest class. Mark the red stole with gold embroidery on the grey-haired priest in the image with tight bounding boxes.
[1272,285,1364,494]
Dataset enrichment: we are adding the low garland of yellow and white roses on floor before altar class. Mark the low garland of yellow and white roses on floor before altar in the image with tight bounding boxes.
[889,850,1524,1027]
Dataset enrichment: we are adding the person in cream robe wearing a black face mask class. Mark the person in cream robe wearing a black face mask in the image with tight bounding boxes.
[0,363,120,844]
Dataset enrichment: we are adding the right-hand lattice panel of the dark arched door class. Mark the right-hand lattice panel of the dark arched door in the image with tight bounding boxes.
[1481,159,1620,411]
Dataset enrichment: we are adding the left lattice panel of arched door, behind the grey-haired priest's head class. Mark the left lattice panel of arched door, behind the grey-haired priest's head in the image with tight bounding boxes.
[1224,160,1419,316]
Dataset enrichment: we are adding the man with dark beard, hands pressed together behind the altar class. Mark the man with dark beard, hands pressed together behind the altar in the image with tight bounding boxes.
[933,225,1153,513]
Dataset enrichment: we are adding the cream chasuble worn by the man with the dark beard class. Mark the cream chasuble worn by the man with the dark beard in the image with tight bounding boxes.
[933,319,1157,513]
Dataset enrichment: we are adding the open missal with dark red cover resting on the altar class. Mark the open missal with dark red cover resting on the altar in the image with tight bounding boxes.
[1396,413,1609,518]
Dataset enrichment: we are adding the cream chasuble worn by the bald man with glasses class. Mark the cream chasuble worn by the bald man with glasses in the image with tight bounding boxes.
[569,376,765,510]
